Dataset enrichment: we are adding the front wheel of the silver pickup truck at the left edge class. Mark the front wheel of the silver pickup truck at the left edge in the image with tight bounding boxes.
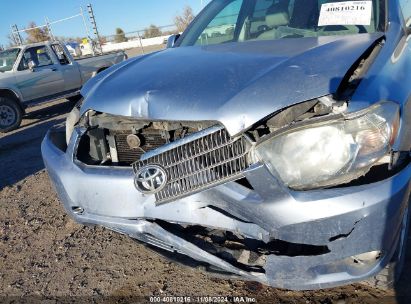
[0,97,23,133]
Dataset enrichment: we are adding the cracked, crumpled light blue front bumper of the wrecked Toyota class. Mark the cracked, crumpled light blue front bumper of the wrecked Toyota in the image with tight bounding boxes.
[42,130,411,290]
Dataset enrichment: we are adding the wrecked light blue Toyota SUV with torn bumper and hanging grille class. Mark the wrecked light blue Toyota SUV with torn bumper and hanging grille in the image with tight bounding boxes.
[42,0,411,290]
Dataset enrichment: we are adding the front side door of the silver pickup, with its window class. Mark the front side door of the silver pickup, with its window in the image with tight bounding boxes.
[16,45,64,100]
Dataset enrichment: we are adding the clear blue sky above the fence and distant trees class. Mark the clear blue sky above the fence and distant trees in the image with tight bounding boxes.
[0,0,210,46]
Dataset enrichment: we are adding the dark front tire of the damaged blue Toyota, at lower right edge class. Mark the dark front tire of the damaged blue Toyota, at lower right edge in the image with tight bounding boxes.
[363,200,411,290]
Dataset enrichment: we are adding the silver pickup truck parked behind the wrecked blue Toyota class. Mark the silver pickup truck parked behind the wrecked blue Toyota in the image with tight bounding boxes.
[0,41,127,133]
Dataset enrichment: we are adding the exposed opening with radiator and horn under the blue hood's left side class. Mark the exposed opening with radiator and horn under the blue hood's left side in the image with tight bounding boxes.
[78,112,216,166]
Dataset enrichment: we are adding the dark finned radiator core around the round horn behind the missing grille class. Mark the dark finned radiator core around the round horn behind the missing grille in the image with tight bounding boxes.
[114,129,167,164]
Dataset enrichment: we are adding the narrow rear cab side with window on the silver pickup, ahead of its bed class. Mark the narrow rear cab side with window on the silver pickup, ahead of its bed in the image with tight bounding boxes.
[51,43,82,92]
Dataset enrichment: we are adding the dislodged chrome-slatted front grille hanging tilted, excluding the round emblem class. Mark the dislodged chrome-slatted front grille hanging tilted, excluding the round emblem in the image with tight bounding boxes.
[133,129,249,203]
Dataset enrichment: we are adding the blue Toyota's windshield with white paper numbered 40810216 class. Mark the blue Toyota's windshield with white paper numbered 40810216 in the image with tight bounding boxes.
[180,0,385,46]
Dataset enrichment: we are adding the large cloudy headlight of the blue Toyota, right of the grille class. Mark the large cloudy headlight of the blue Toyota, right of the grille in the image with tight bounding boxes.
[256,102,399,189]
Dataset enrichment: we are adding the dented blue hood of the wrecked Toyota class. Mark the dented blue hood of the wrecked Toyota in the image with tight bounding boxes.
[81,33,382,135]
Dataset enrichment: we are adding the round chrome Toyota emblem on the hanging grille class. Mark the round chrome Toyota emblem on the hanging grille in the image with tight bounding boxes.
[134,165,167,194]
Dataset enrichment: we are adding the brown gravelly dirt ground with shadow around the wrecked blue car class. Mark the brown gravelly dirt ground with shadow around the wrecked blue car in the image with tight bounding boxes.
[0,48,411,304]
